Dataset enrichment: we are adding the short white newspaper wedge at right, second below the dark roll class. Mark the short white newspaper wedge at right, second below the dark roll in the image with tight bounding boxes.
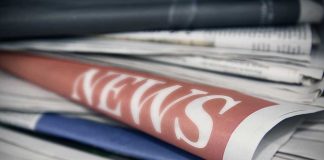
[144,56,323,85]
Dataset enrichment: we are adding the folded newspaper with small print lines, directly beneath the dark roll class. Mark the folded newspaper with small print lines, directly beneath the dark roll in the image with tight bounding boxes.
[0,25,320,63]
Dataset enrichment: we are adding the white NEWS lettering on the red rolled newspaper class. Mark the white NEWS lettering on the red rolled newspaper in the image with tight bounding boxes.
[71,69,240,148]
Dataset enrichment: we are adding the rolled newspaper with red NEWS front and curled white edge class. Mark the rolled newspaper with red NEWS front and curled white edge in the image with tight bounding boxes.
[0,51,323,159]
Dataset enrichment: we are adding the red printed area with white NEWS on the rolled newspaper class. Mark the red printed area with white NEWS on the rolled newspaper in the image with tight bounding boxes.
[0,52,275,159]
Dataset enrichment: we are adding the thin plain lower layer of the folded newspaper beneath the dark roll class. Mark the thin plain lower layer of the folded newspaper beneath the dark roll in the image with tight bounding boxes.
[0,36,311,64]
